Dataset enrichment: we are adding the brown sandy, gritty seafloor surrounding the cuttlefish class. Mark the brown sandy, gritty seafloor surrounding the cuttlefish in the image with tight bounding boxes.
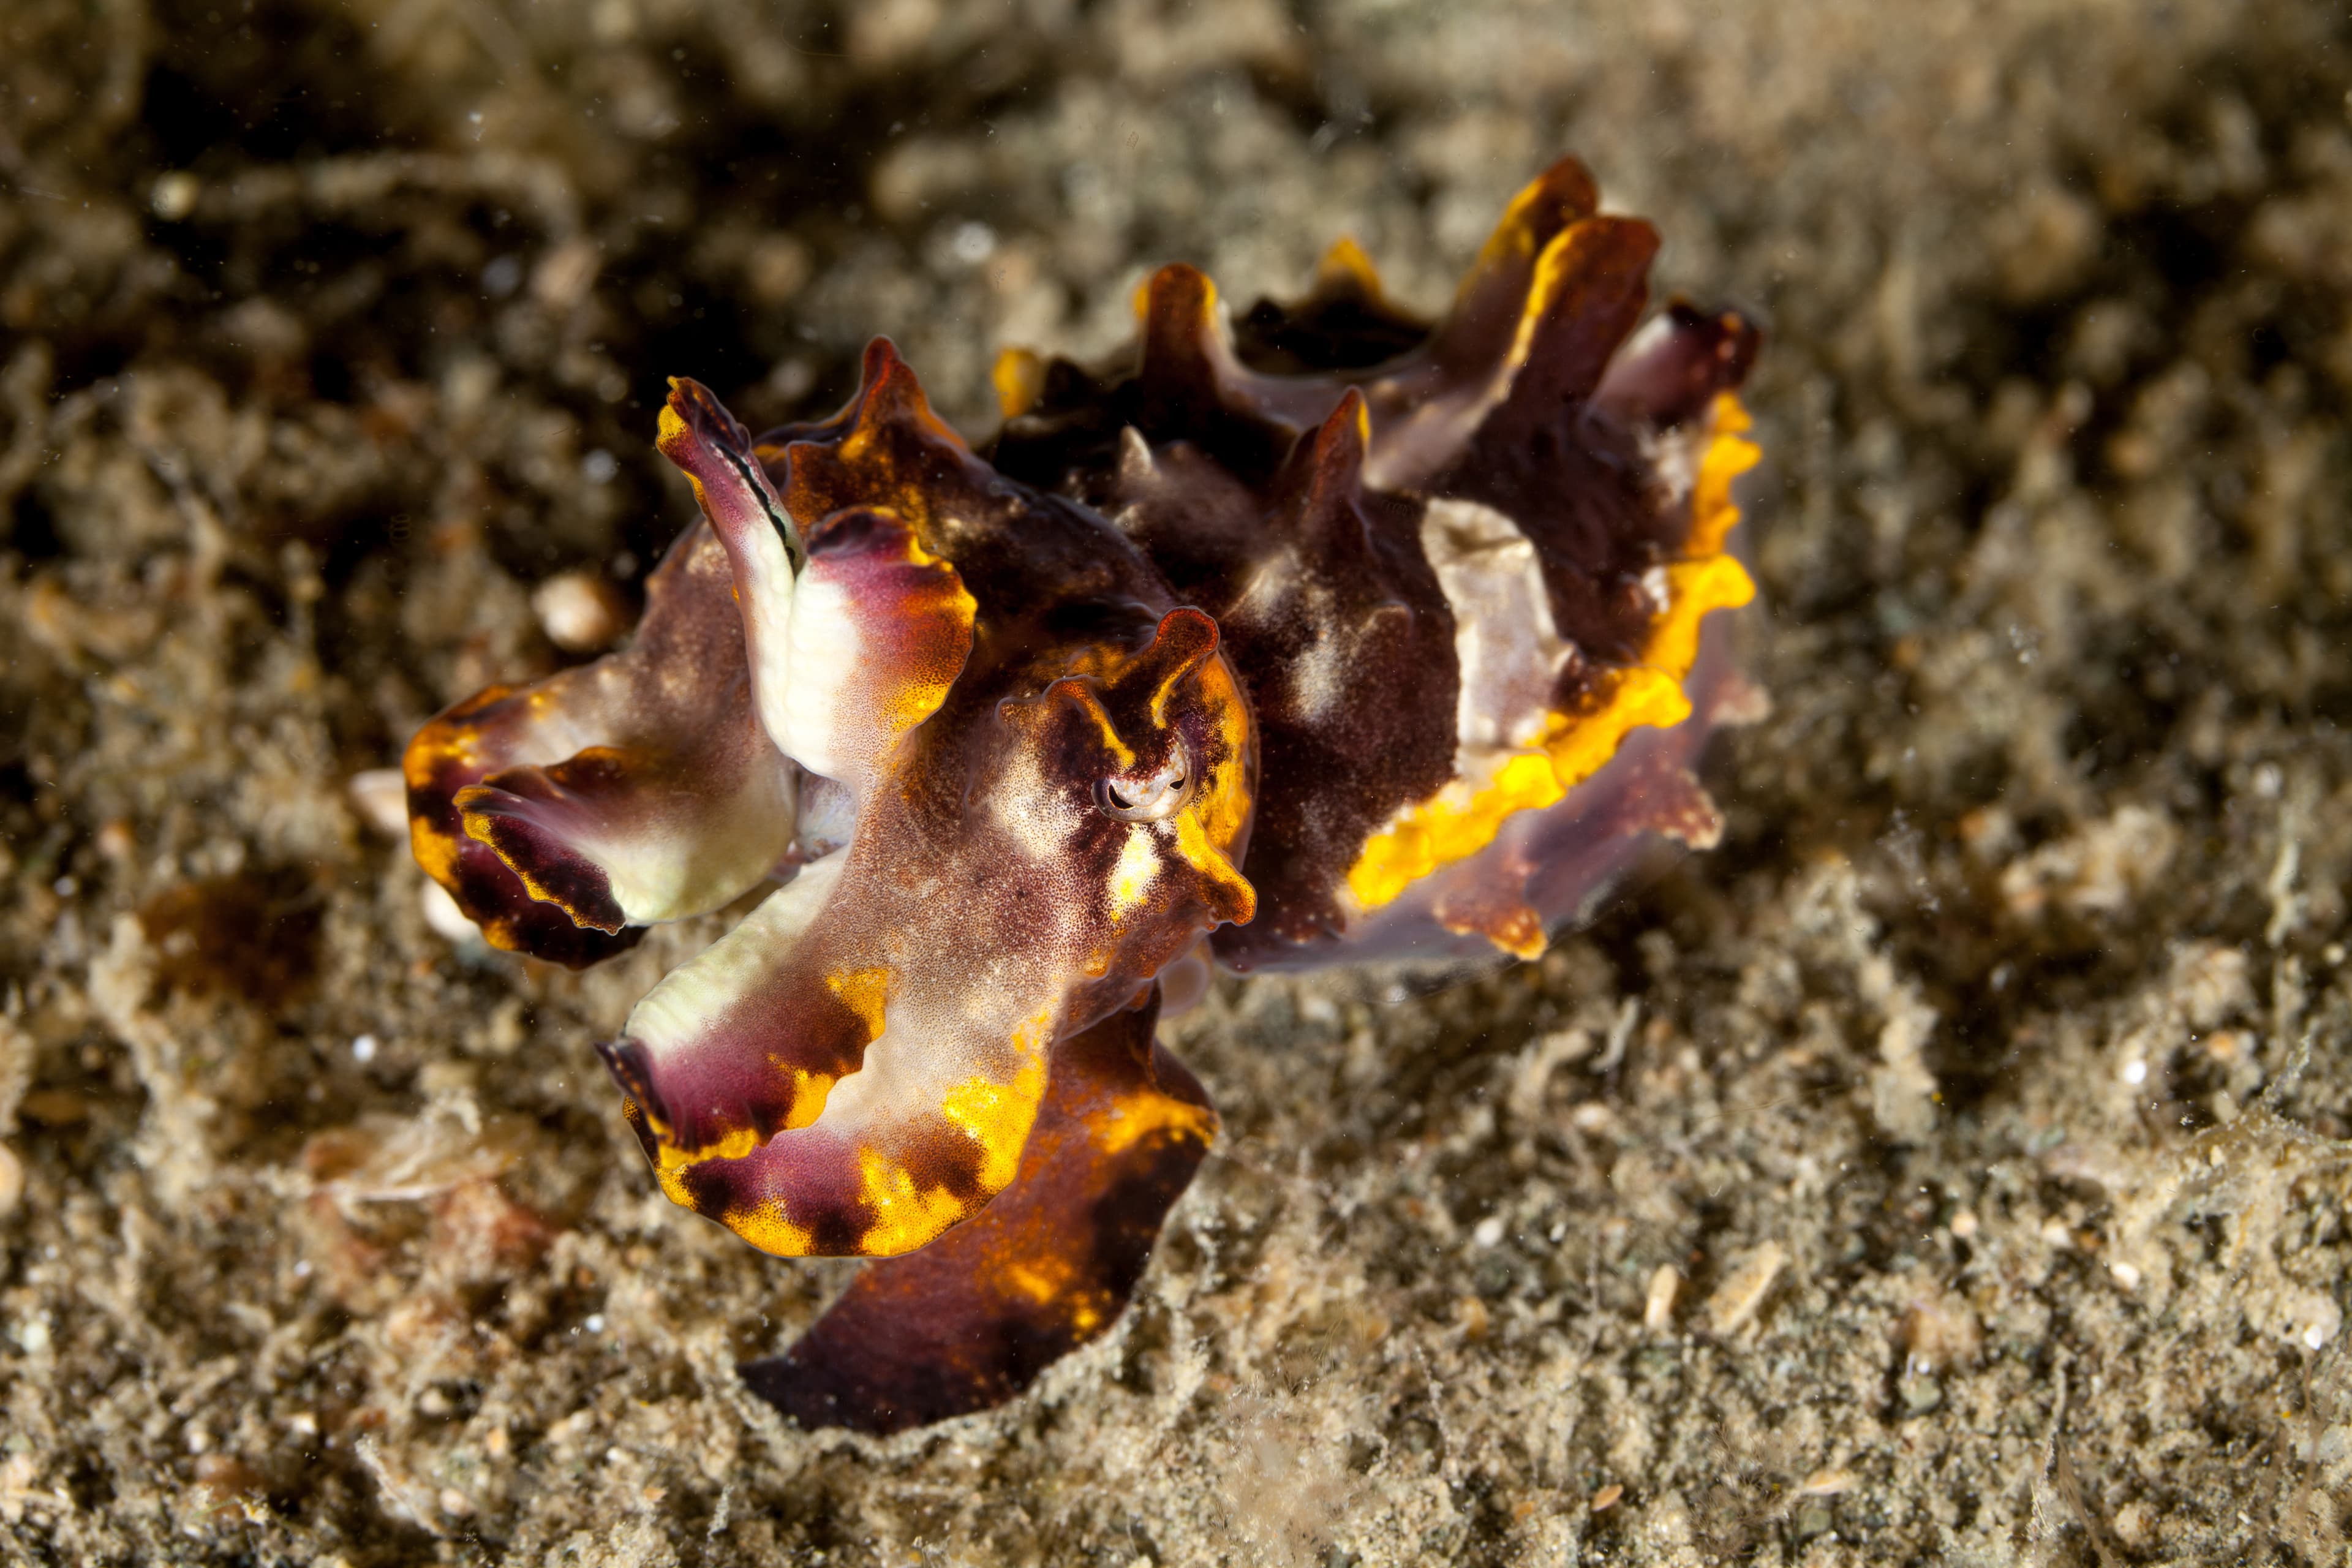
[0,0,2352,1568]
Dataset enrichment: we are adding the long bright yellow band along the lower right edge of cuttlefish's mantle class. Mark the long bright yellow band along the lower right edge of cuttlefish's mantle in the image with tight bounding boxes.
[1348,393,1759,926]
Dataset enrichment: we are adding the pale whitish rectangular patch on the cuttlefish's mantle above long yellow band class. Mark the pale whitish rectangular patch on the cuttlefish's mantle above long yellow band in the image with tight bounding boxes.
[1420,501,1576,756]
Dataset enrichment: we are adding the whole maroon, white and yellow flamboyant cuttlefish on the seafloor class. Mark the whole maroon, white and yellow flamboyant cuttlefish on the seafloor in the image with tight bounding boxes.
[404,162,1757,1431]
